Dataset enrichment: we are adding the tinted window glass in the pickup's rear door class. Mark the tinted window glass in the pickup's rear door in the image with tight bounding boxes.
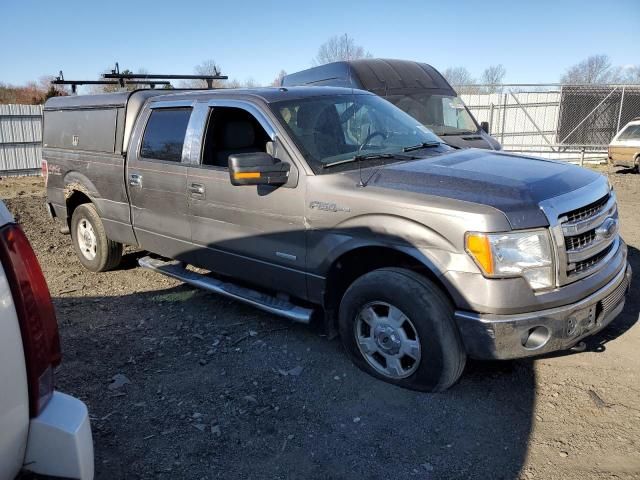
[140,107,191,162]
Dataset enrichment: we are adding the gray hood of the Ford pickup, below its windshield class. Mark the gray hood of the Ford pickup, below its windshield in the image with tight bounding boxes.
[356,149,600,229]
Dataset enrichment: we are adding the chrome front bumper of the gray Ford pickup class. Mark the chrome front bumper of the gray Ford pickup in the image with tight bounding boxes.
[455,263,631,359]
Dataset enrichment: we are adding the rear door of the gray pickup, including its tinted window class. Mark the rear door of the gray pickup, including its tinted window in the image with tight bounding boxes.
[126,101,194,259]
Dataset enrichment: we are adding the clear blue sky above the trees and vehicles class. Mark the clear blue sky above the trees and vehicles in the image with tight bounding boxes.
[0,0,640,88]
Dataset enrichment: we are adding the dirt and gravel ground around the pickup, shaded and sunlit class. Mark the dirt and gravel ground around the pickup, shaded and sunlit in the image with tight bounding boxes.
[0,170,640,480]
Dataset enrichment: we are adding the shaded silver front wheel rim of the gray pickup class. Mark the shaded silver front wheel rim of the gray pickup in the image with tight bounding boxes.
[355,301,422,379]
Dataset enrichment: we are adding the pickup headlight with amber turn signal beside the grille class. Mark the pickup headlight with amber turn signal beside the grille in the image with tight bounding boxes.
[465,230,554,290]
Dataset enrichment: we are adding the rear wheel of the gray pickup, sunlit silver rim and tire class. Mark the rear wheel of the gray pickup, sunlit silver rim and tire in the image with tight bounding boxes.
[70,203,122,272]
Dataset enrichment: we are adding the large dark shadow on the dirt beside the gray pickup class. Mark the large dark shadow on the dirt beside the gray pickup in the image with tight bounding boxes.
[55,287,535,480]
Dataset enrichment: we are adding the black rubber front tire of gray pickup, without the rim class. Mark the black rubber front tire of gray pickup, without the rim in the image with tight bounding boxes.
[339,269,461,391]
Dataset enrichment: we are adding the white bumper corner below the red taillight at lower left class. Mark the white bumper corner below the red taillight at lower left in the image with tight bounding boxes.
[24,392,93,480]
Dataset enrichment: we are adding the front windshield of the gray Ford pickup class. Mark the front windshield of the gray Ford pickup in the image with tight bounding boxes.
[271,94,442,167]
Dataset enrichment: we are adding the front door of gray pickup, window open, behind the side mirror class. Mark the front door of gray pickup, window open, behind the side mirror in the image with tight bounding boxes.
[187,100,306,298]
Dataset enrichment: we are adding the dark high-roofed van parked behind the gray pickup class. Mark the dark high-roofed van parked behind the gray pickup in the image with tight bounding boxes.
[282,58,502,150]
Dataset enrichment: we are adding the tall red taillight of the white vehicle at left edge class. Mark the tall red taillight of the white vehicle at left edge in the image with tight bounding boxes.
[0,224,61,417]
